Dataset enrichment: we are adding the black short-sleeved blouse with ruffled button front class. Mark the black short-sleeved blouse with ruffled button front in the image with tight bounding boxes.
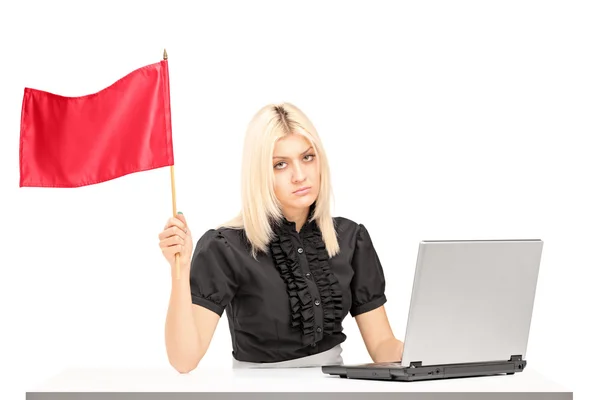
[190,211,386,362]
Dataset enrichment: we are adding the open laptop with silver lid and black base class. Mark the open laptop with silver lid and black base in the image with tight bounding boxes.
[321,239,543,381]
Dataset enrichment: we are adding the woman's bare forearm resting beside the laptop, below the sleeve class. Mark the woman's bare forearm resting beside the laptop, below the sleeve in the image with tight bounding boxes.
[356,306,404,362]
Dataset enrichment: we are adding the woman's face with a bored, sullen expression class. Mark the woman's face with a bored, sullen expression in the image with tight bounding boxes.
[273,134,321,211]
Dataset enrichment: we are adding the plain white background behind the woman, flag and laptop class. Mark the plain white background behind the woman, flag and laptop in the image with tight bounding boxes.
[0,0,600,399]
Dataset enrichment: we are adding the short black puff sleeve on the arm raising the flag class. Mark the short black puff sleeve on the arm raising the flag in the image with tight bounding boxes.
[190,229,238,316]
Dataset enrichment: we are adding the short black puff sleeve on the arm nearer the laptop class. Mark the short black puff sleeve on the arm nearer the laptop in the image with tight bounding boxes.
[350,224,386,317]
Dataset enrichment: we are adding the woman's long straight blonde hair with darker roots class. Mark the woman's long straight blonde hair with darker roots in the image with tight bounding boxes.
[220,103,340,259]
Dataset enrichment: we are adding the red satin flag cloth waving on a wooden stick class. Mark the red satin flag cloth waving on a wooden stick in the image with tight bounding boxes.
[19,60,174,187]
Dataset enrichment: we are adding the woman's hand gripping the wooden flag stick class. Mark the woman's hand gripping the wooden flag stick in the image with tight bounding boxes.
[158,213,193,272]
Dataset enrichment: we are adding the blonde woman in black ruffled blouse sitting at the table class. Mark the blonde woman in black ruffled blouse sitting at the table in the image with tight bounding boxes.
[159,103,403,373]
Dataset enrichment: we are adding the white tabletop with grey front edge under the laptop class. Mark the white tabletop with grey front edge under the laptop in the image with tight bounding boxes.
[27,367,573,400]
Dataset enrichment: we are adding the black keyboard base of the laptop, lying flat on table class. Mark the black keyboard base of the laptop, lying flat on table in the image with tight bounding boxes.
[321,356,527,382]
